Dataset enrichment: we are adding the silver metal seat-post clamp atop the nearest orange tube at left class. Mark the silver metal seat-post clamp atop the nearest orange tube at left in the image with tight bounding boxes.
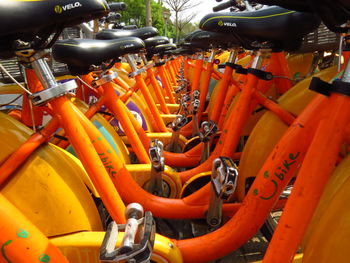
[29,79,77,106]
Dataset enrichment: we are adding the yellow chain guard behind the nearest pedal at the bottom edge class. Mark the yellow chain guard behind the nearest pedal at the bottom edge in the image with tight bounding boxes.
[50,232,182,263]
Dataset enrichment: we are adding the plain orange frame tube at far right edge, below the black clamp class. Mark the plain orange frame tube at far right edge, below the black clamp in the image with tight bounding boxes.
[263,54,350,262]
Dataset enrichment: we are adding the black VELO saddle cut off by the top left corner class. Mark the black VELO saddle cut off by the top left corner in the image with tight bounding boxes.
[0,0,109,58]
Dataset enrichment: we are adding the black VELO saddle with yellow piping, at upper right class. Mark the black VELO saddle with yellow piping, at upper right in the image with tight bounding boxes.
[199,7,320,51]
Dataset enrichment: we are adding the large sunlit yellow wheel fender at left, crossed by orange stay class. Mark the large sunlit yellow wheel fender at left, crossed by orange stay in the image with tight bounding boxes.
[0,113,102,236]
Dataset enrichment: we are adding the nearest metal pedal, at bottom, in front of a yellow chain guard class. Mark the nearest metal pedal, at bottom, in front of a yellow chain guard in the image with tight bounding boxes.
[100,203,155,263]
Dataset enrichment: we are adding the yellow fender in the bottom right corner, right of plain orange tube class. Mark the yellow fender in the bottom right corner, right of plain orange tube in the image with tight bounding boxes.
[303,155,350,263]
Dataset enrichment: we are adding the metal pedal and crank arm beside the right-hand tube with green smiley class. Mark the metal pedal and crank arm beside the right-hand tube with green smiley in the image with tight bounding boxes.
[207,156,238,227]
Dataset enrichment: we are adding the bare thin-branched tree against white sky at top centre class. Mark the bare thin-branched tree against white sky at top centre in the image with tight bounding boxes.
[163,0,200,42]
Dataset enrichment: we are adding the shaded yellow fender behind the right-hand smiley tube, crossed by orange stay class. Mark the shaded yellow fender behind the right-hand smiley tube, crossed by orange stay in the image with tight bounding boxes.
[235,67,337,201]
